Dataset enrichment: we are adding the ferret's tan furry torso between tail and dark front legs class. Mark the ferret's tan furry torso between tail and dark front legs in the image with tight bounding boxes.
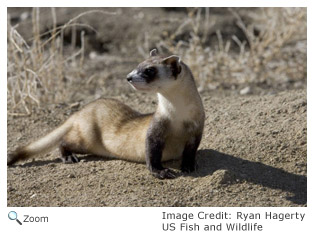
[63,99,152,162]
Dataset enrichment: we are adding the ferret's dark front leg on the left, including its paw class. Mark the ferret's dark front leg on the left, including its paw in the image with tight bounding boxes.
[146,120,176,179]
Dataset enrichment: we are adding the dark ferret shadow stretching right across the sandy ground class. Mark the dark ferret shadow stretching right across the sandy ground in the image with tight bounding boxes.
[186,149,307,205]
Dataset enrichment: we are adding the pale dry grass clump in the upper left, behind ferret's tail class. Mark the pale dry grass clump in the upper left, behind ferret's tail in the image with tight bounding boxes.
[7,8,114,116]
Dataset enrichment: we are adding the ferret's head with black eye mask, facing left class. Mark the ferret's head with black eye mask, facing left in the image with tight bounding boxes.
[127,49,182,92]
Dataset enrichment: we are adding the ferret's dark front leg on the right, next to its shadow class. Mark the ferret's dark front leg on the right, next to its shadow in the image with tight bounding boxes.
[181,136,201,173]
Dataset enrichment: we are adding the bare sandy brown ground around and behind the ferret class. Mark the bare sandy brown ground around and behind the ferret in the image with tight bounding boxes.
[7,9,307,207]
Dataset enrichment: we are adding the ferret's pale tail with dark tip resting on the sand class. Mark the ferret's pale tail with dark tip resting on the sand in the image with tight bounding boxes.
[7,120,72,165]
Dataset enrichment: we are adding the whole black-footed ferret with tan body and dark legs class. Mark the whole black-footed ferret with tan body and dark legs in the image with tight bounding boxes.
[7,49,205,179]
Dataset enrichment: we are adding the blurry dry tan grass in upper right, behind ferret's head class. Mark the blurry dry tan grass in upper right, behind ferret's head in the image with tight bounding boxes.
[154,8,306,90]
